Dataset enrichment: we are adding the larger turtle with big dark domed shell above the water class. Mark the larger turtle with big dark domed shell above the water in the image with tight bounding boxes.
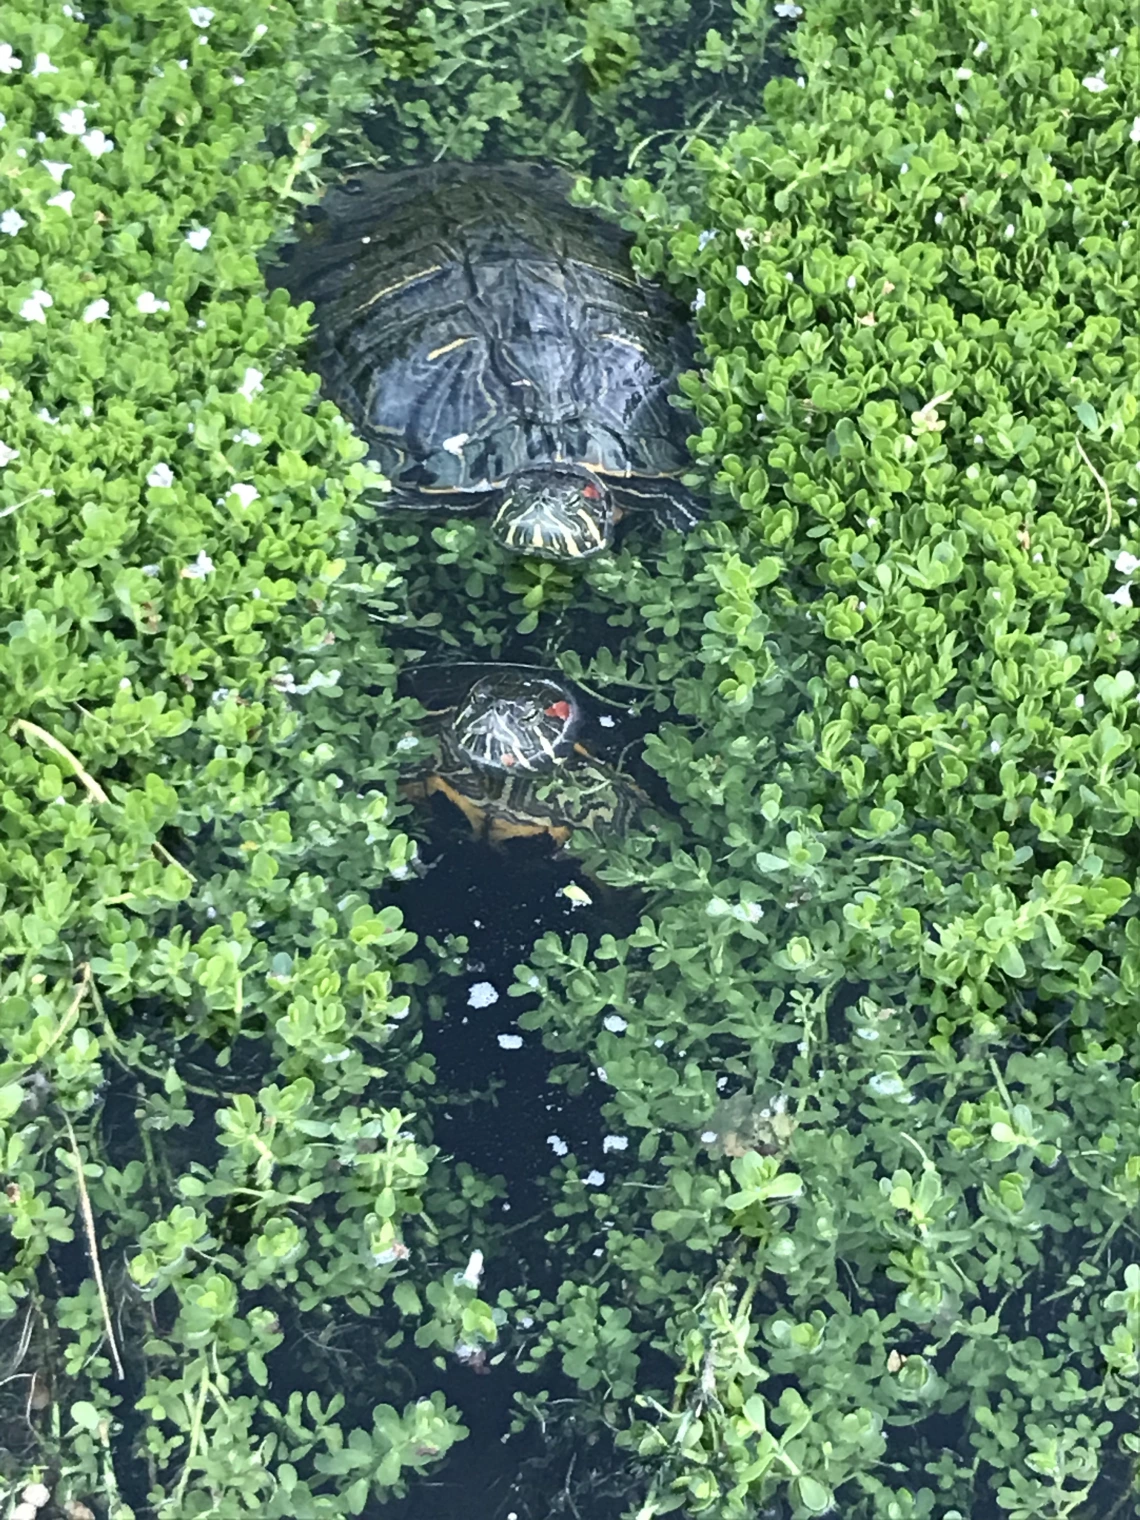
[271,163,699,559]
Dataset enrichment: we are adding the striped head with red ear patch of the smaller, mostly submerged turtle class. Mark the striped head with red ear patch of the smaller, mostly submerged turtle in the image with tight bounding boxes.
[454,670,579,772]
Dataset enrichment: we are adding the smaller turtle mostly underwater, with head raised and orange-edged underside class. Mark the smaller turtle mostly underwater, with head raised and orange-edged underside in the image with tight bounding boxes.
[401,666,649,847]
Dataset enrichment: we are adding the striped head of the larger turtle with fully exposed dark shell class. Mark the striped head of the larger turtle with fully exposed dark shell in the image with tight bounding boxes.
[491,464,617,559]
